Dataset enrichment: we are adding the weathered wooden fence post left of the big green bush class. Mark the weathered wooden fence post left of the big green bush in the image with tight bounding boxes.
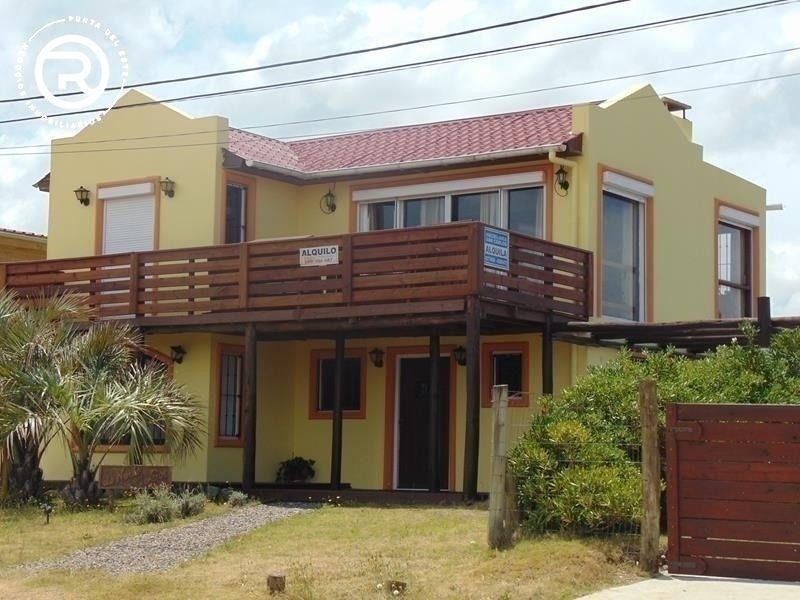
[489,384,514,549]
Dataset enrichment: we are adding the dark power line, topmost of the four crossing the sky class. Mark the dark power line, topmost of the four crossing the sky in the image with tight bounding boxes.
[0,0,632,105]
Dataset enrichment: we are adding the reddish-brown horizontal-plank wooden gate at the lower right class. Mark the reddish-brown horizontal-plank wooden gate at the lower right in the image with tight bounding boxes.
[666,404,800,581]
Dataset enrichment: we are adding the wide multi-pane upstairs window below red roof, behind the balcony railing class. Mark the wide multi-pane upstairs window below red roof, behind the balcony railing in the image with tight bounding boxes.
[353,171,545,237]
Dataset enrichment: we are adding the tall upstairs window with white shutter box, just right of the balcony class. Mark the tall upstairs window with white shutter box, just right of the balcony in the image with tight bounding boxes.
[600,171,653,321]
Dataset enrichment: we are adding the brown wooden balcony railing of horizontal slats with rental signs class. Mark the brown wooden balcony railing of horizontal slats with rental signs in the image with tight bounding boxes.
[0,222,592,325]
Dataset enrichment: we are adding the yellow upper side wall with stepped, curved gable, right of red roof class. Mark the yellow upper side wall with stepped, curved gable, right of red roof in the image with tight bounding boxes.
[568,86,766,321]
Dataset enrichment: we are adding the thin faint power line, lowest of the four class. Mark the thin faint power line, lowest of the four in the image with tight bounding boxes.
[6,71,800,156]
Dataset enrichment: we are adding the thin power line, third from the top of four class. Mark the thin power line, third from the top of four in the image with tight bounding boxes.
[0,46,800,150]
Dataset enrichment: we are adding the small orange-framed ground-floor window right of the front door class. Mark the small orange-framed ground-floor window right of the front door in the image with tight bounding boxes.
[481,342,530,408]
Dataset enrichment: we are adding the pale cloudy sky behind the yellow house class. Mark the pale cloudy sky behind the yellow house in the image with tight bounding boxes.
[0,0,800,316]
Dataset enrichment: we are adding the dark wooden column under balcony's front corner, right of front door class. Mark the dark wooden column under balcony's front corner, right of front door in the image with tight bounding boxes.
[462,296,481,501]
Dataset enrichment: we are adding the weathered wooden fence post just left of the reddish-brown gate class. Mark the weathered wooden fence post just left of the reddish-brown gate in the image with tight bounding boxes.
[639,379,661,574]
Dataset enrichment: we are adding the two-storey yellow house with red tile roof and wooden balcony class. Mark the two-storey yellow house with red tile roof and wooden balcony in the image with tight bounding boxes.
[8,86,765,496]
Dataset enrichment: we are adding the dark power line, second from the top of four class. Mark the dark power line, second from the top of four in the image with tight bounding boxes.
[0,0,798,125]
